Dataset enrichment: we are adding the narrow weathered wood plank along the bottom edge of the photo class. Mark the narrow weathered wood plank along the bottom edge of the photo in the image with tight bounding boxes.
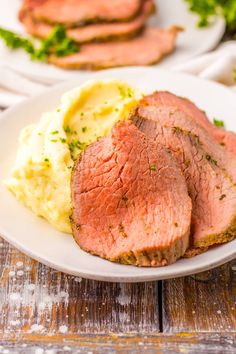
[0,333,236,354]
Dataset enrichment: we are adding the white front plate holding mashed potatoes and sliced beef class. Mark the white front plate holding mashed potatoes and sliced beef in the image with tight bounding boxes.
[0,68,236,282]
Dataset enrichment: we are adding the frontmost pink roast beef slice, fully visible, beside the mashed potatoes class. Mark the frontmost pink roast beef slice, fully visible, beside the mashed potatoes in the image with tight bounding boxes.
[72,122,191,266]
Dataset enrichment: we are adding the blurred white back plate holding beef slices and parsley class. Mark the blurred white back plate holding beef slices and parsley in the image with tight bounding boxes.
[0,0,225,82]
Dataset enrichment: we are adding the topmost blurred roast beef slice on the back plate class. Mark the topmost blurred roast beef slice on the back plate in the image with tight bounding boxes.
[20,0,142,27]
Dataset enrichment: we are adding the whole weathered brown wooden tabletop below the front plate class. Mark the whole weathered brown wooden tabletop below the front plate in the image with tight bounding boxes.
[0,236,236,354]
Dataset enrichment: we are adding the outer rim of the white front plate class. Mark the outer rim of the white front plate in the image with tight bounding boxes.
[0,67,236,282]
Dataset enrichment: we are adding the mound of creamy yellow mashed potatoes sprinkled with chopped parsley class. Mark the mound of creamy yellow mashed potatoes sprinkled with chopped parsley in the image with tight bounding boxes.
[5,80,142,233]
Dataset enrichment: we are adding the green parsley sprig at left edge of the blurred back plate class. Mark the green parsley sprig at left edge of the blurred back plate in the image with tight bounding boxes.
[0,26,79,61]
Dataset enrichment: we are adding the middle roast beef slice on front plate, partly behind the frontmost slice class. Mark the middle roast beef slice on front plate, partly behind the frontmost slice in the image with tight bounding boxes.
[132,93,236,255]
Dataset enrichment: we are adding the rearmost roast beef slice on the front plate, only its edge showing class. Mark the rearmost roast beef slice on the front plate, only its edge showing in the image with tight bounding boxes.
[151,91,236,154]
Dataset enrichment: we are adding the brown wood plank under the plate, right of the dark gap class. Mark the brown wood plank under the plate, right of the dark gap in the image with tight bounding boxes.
[163,260,236,333]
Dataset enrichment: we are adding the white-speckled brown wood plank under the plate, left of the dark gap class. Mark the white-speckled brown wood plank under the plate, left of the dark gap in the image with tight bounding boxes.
[0,235,159,340]
